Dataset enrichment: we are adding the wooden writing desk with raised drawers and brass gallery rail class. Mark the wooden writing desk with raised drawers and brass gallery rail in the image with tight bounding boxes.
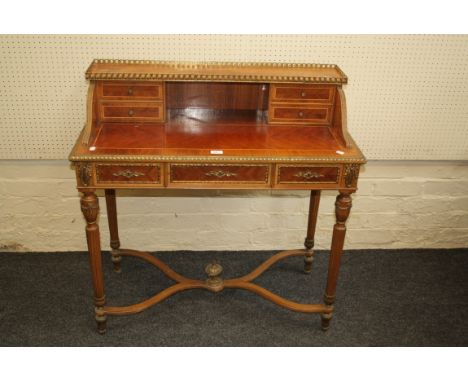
[69,60,365,333]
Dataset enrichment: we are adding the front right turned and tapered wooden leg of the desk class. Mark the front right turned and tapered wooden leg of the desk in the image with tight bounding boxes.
[322,191,351,330]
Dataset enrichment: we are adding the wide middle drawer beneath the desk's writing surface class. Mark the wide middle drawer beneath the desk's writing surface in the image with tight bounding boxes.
[169,163,270,186]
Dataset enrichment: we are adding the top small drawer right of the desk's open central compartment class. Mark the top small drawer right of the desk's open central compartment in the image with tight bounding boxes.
[270,84,335,103]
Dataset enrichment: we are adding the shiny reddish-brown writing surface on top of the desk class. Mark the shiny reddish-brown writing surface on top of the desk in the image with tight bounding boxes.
[92,118,343,155]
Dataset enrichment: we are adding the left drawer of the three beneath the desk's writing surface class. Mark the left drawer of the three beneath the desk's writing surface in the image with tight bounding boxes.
[96,163,162,185]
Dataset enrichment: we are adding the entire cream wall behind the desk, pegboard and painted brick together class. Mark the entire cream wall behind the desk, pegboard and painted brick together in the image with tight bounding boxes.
[0,35,468,251]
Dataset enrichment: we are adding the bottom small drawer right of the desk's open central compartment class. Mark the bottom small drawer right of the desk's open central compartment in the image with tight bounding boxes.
[268,103,332,124]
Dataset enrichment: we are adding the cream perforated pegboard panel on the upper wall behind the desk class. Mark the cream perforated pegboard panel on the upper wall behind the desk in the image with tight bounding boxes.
[0,35,468,160]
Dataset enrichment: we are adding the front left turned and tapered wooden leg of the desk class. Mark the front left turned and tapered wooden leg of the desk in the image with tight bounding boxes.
[81,190,106,334]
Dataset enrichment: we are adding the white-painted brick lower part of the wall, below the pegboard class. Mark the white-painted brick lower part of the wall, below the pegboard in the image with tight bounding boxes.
[0,160,468,251]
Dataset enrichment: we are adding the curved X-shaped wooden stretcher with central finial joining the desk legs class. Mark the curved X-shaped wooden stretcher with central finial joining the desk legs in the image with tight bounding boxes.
[103,249,333,315]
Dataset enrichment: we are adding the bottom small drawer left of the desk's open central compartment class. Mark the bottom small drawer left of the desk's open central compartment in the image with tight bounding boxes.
[99,101,164,122]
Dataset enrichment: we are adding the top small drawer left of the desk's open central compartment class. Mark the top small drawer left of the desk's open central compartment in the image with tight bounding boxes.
[99,81,164,100]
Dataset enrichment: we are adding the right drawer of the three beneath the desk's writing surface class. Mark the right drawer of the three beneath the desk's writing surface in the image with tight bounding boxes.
[275,164,341,184]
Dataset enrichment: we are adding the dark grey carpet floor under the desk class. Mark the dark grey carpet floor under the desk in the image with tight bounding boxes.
[0,249,468,346]
